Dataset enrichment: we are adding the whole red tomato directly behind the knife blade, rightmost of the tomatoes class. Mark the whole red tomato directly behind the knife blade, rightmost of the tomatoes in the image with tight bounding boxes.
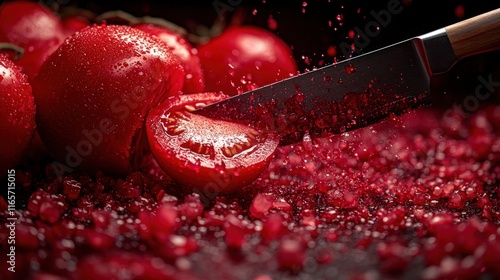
[198,26,297,95]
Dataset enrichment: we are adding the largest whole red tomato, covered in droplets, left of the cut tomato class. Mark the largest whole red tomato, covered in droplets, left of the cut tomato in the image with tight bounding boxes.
[33,25,184,175]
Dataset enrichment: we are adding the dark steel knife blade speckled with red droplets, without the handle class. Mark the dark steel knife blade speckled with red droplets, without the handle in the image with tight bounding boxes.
[196,40,430,144]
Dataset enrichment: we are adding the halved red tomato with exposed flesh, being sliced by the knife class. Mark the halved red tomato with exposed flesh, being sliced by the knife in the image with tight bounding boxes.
[146,93,279,194]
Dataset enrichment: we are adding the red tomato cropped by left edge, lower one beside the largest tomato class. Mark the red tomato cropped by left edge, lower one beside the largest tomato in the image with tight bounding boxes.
[0,55,35,173]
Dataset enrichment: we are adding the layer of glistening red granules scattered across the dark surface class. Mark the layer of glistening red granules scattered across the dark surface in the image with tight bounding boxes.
[0,106,500,280]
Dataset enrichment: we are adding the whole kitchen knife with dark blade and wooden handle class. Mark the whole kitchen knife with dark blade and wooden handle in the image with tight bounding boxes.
[195,9,500,144]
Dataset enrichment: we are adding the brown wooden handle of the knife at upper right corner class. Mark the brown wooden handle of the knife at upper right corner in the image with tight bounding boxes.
[445,9,500,60]
